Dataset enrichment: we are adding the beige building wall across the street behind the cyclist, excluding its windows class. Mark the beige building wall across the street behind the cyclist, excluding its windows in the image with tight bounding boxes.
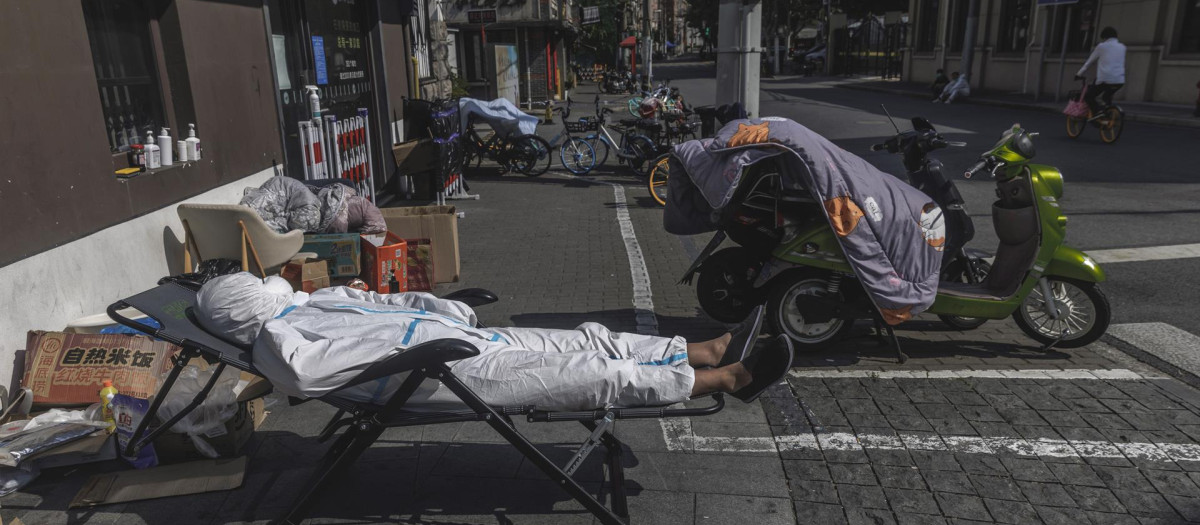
[905,0,1200,104]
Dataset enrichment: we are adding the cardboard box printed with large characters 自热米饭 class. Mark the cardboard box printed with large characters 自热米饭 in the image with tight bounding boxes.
[22,331,179,406]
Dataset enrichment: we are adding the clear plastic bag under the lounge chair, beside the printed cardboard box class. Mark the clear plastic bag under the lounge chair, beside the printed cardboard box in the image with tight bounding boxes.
[158,366,239,459]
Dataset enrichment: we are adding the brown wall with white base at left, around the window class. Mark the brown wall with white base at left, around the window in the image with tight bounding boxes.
[0,0,283,390]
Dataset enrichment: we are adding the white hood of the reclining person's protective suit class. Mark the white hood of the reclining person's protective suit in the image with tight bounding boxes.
[196,272,294,344]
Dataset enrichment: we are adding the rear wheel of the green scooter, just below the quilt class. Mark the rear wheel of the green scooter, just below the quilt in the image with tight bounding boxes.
[767,270,854,352]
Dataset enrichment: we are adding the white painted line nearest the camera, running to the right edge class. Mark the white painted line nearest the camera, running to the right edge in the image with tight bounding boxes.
[668,432,1200,461]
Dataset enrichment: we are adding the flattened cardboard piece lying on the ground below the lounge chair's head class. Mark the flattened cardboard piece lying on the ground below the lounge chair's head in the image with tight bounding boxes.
[67,455,246,508]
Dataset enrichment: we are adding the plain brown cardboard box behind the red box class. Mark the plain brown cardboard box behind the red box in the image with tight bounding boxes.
[380,206,458,283]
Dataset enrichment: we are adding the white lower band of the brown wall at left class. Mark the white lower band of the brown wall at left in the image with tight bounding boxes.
[0,168,274,388]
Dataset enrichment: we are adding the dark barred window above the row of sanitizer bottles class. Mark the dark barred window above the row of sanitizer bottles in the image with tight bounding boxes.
[83,0,167,152]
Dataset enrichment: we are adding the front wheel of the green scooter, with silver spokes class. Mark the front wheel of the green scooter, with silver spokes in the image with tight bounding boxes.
[1013,277,1112,348]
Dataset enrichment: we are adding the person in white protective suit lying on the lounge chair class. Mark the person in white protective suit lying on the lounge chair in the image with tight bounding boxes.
[197,272,792,410]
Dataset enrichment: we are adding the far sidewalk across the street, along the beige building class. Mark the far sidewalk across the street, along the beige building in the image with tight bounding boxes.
[830,78,1200,127]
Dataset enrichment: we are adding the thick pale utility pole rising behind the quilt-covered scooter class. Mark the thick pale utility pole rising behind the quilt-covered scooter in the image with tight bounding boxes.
[716,0,762,116]
